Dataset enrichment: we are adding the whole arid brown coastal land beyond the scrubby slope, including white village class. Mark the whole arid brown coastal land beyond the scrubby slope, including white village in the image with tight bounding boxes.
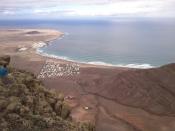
[0,29,175,131]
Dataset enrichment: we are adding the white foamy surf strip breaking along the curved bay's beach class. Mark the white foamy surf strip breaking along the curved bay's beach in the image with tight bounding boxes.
[37,48,154,69]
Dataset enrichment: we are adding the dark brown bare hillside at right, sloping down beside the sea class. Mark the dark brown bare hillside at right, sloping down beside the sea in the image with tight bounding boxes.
[89,64,175,116]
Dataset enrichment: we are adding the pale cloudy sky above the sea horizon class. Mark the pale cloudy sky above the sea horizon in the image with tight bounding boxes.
[0,0,175,19]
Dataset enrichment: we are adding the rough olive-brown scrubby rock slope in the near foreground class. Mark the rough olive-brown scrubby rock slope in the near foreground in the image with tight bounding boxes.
[0,68,94,131]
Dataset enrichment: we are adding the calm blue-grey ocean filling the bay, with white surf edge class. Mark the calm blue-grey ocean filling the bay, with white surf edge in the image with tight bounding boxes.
[0,19,175,68]
